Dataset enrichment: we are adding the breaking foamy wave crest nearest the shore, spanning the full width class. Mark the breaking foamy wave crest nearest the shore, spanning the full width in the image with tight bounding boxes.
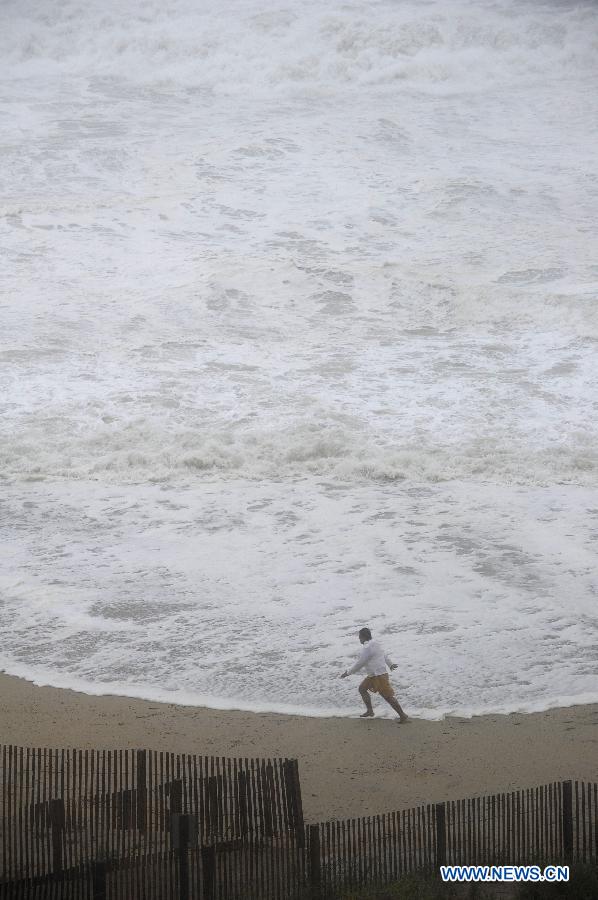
[0,422,598,485]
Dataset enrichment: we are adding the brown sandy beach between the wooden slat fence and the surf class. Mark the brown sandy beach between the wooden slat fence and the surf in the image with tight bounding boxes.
[0,674,598,821]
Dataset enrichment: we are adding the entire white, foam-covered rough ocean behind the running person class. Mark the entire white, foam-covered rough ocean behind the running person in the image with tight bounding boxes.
[0,0,598,718]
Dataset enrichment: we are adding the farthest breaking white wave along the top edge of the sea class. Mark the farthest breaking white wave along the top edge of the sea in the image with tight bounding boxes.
[0,0,596,94]
